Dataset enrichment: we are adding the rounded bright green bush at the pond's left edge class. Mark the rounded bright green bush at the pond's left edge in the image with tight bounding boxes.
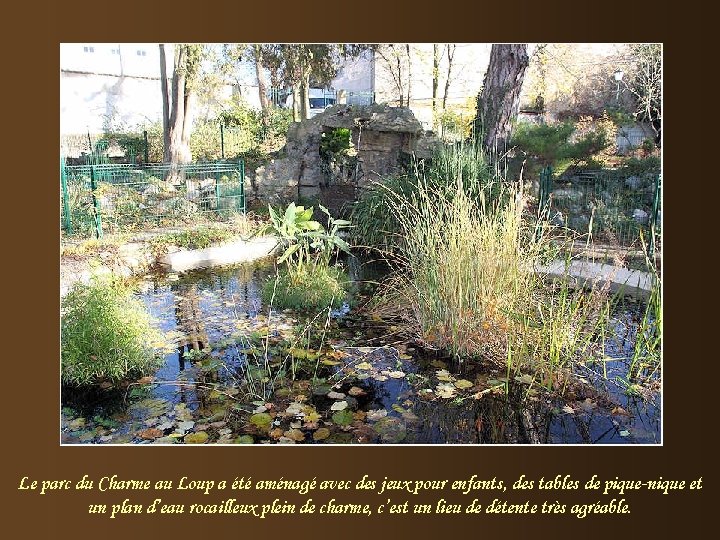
[61,277,163,386]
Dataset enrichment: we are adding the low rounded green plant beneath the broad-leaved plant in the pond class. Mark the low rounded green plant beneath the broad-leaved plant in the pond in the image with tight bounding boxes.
[262,265,349,311]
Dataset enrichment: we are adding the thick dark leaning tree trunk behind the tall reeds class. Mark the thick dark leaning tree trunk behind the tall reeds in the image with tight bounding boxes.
[475,44,529,155]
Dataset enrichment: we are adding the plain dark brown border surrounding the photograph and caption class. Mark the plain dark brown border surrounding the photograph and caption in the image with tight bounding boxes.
[2,0,714,538]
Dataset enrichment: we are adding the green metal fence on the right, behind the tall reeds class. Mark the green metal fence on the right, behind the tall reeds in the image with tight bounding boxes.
[539,167,661,251]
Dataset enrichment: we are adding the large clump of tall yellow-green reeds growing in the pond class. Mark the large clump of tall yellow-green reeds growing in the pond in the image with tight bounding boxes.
[377,143,607,382]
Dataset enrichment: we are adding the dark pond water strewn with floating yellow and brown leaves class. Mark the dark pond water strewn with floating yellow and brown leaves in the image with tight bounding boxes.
[62,263,661,444]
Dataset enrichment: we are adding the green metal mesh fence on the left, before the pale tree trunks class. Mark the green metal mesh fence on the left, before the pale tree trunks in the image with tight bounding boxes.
[60,158,245,238]
